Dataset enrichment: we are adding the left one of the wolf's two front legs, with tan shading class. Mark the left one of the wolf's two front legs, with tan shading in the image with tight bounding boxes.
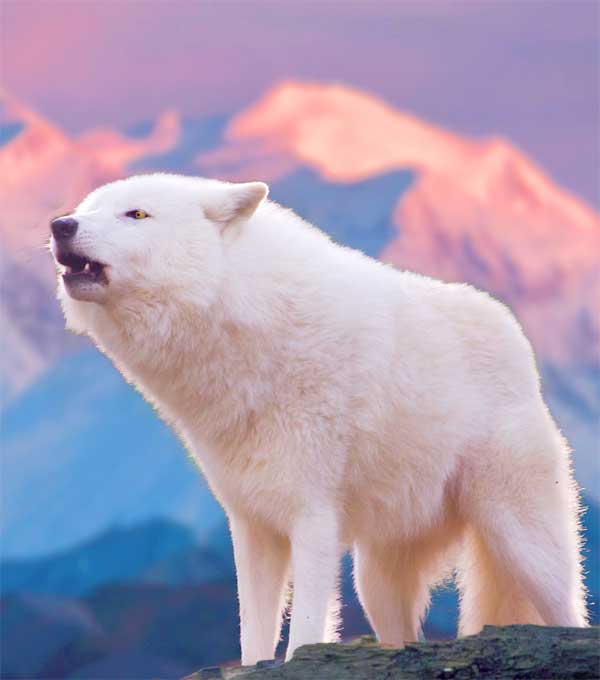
[229,517,290,666]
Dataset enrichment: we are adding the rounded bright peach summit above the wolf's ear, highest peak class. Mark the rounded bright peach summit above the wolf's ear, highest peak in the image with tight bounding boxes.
[203,82,471,182]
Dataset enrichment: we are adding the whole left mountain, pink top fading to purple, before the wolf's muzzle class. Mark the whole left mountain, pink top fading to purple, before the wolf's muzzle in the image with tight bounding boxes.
[0,93,185,401]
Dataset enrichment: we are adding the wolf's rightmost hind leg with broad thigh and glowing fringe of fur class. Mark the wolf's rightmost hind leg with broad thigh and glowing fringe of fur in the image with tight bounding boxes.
[459,417,587,635]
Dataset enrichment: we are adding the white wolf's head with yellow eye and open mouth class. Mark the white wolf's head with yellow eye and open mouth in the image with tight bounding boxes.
[50,174,268,330]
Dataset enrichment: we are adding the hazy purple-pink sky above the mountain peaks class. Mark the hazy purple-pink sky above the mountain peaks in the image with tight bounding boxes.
[1,0,600,207]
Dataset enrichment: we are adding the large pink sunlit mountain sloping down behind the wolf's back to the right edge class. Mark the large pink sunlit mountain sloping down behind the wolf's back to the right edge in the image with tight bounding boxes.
[197,83,600,363]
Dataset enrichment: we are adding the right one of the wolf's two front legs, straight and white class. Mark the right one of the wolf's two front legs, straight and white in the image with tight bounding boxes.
[286,510,340,661]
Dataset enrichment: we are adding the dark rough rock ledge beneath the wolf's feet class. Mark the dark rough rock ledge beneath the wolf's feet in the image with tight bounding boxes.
[186,626,600,680]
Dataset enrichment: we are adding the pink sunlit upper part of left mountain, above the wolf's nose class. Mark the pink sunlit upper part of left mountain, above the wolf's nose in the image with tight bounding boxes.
[0,94,181,253]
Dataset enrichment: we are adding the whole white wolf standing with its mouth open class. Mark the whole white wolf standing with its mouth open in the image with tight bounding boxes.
[51,174,586,664]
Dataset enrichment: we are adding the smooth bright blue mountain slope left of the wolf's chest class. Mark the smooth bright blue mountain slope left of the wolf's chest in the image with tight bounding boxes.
[0,349,223,559]
